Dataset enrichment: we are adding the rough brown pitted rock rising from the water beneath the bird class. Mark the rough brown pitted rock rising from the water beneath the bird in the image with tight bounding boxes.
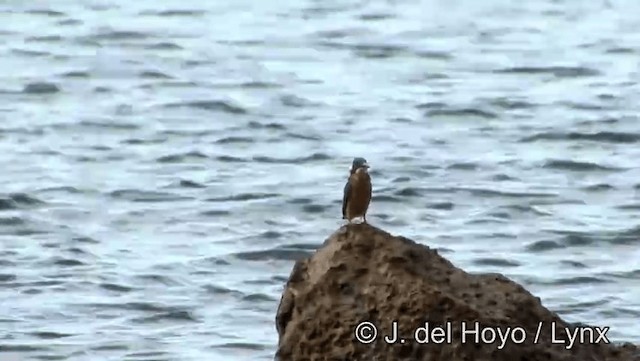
[275,224,640,361]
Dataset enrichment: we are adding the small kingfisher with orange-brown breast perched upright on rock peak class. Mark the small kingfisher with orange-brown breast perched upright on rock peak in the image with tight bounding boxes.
[342,157,371,223]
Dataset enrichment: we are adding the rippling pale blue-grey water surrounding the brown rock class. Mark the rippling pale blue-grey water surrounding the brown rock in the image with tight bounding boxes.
[0,0,640,361]
